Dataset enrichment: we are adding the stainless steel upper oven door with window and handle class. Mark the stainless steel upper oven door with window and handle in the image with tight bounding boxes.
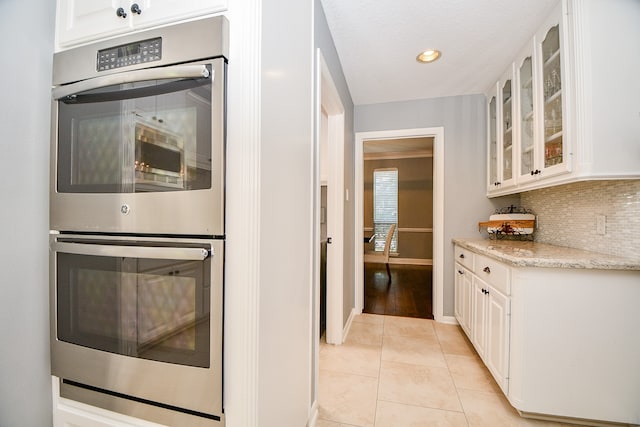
[50,58,225,235]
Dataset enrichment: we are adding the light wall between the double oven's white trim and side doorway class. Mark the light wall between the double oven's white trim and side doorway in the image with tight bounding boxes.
[260,0,314,427]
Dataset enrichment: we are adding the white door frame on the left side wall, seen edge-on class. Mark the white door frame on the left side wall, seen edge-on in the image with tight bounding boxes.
[316,49,345,344]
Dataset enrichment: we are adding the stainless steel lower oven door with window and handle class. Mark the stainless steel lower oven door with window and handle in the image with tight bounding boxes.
[50,235,223,419]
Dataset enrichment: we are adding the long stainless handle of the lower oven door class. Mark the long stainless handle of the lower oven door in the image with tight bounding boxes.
[51,242,212,261]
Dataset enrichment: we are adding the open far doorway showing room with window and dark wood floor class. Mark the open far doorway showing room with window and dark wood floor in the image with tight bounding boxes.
[363,136,434,319]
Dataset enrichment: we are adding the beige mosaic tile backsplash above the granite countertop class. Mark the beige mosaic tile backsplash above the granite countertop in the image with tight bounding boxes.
[520,180,640,259]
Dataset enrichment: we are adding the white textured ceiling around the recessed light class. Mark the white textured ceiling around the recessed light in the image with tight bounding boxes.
[321,0,558,105]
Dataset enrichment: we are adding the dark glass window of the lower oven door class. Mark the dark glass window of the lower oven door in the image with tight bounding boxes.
[57,253,211,368]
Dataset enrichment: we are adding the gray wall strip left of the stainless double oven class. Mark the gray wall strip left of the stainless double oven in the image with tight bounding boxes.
[0,0,55,427]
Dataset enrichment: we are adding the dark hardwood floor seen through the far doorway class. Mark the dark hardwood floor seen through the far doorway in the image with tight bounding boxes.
[364,264,433,319]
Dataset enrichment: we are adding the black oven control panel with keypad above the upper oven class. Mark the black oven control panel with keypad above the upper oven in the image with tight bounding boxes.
[96,37,162,71]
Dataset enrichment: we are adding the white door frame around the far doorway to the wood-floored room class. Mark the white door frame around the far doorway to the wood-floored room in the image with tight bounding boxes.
[353,127,447,322]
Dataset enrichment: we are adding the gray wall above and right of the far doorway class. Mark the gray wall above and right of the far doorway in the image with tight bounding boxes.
[354,95,519,316]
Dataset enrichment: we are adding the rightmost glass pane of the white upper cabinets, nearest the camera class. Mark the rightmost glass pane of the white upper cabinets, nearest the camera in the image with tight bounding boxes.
[542,25,563,167]
